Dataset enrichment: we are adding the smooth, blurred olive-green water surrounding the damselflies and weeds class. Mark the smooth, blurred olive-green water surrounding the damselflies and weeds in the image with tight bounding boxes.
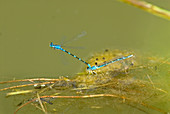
[0,0,170,114]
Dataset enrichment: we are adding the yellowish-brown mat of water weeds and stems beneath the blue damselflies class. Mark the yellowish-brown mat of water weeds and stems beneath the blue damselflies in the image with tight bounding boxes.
[0,49,170,113]
